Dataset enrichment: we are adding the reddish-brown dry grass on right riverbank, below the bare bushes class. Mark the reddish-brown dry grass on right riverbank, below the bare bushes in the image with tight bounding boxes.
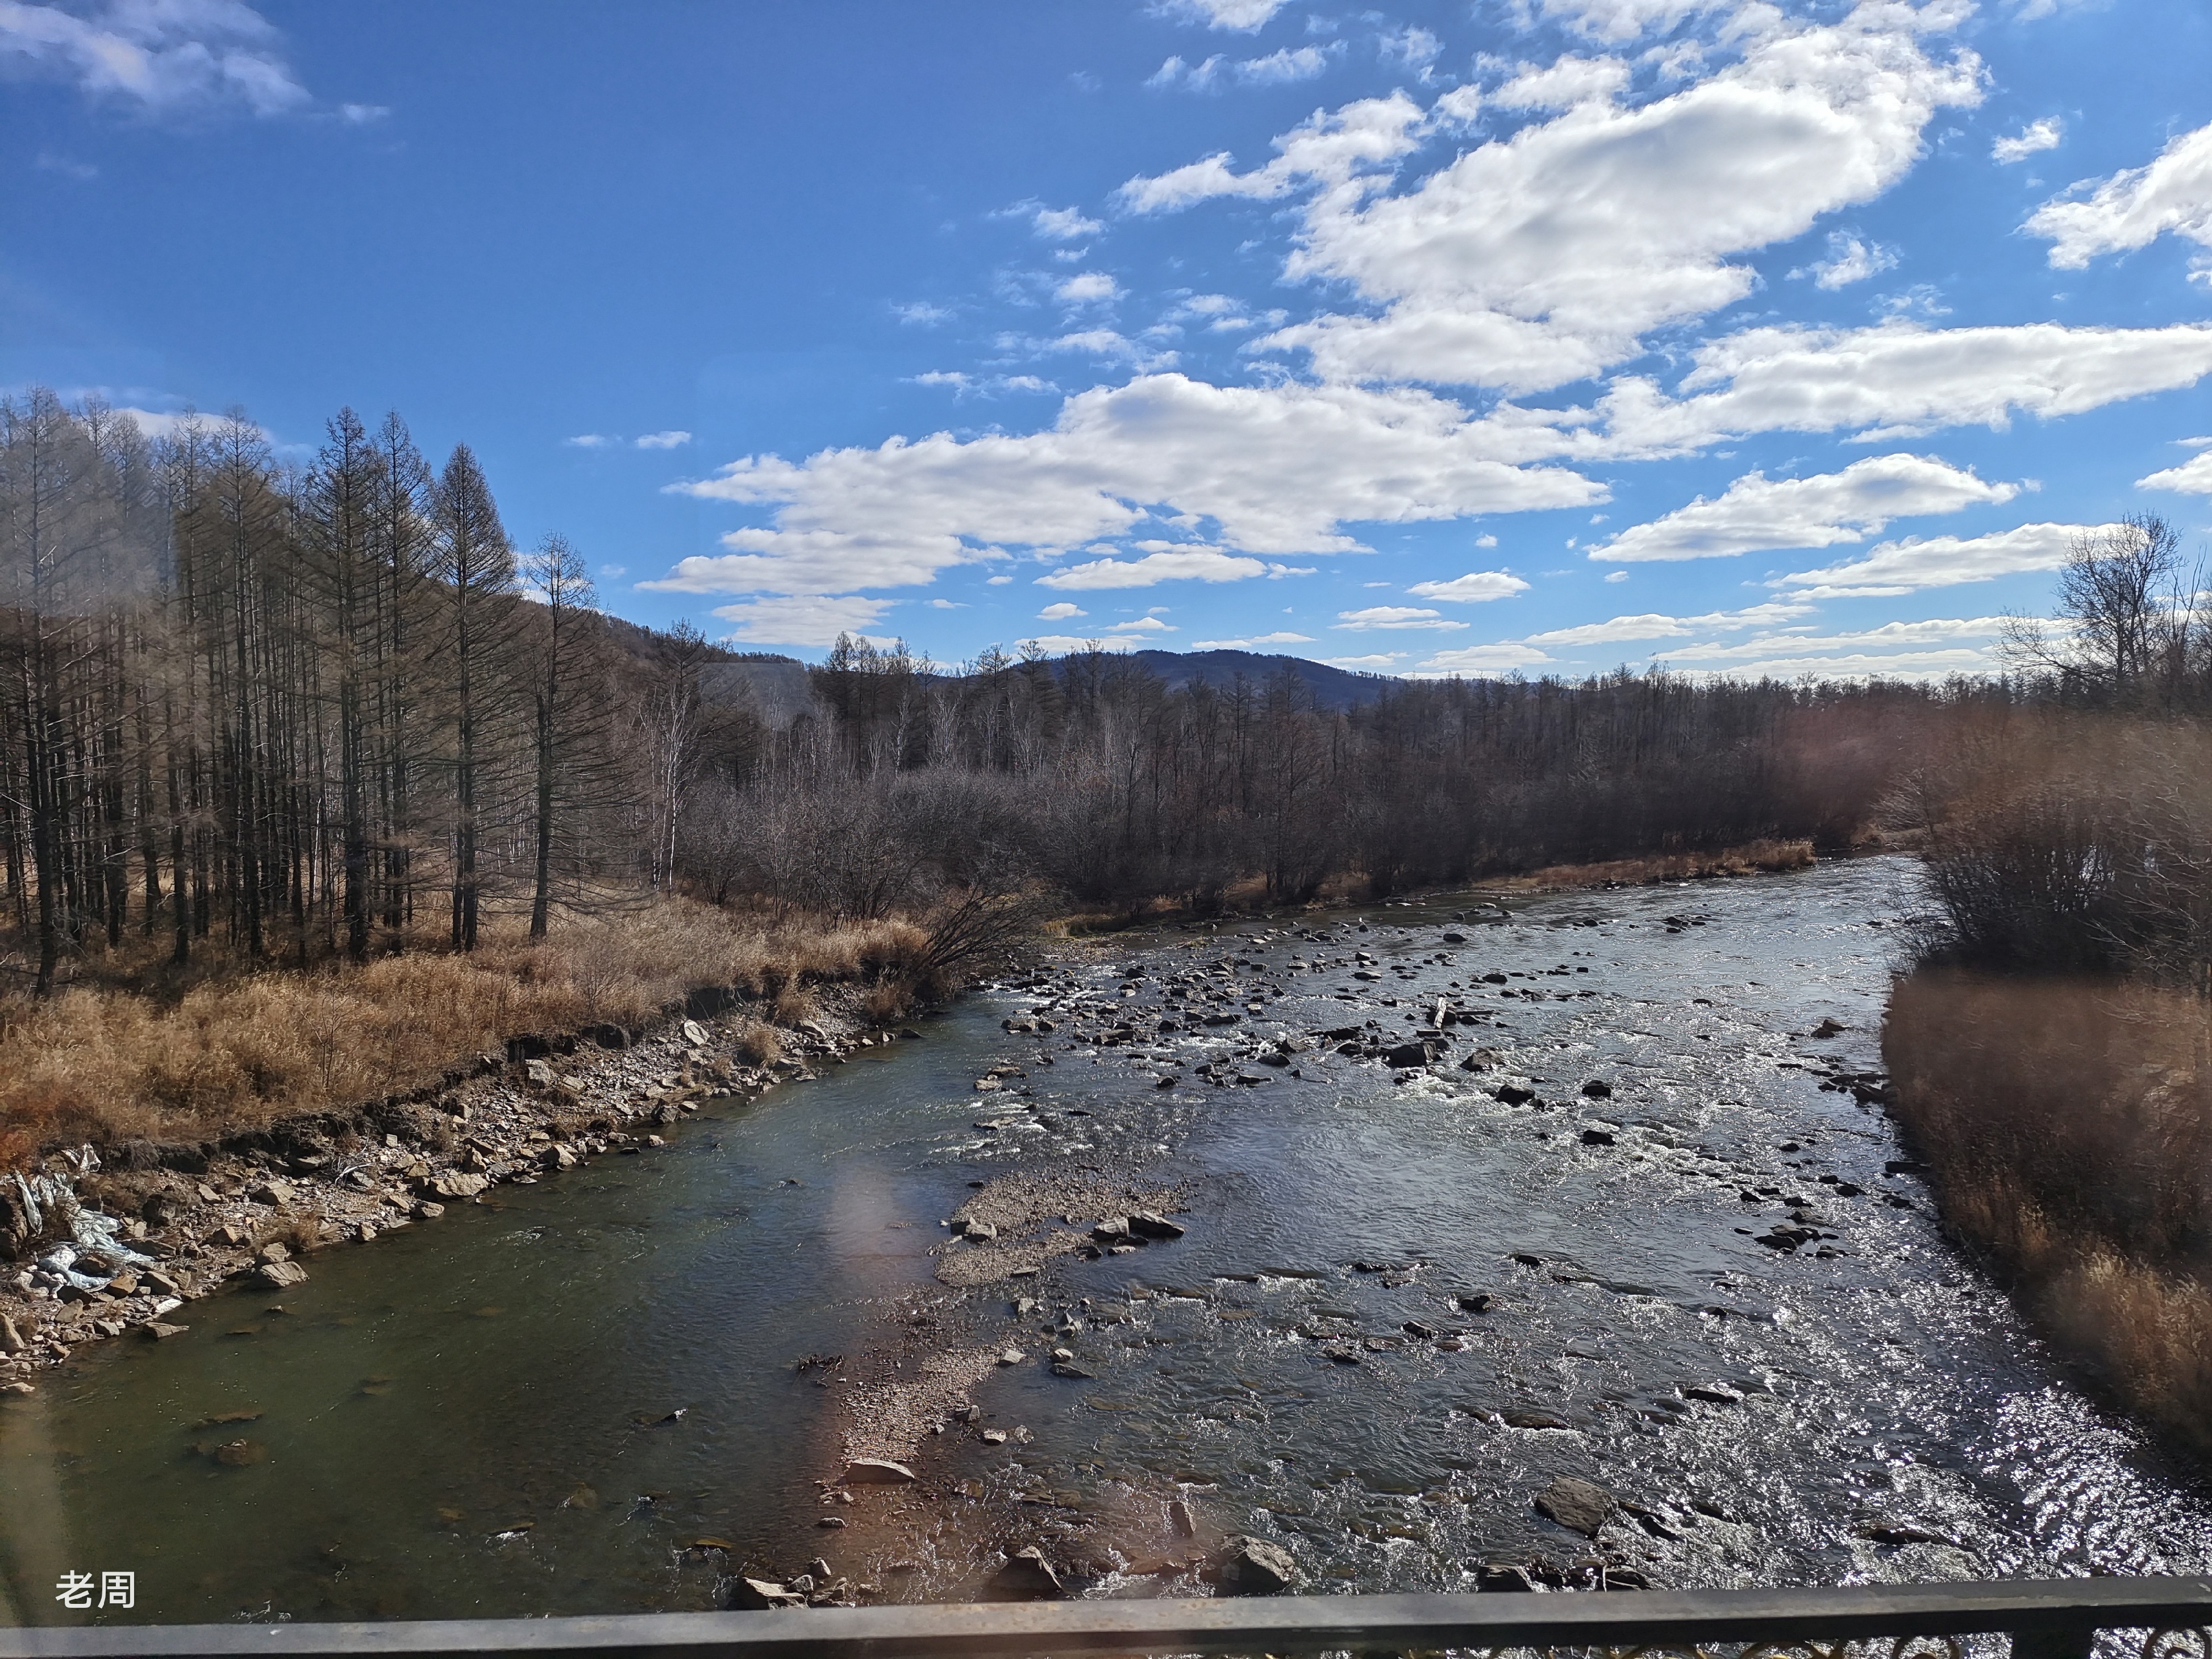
[1882,969,2212,1453]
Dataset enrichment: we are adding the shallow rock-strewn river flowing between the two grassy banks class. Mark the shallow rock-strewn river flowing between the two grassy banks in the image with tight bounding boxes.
[0,861,2212,1622]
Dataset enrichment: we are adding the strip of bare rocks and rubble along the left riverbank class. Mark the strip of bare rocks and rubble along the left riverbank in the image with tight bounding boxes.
[0,986,914,1396]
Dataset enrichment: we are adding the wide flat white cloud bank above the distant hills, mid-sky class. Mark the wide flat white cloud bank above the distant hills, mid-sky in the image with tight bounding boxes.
[668,374,1603,593]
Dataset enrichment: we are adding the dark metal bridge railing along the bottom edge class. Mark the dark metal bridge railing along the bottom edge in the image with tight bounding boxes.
[0,1579,2212,1659]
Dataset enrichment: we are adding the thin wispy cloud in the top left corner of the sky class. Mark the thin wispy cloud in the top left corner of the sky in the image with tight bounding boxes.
[0,0,310,115]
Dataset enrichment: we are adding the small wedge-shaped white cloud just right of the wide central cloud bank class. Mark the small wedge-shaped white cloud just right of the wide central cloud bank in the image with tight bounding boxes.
[1588,453,2019,564]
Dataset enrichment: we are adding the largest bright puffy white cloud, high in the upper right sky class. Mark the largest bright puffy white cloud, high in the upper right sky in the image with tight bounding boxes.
[1220,0,1982,391]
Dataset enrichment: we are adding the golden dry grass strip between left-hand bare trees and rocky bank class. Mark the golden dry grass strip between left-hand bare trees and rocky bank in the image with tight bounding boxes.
[0,898,927,1168]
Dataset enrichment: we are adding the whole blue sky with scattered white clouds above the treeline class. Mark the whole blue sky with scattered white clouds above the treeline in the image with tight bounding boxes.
[0,0,2212,674]
